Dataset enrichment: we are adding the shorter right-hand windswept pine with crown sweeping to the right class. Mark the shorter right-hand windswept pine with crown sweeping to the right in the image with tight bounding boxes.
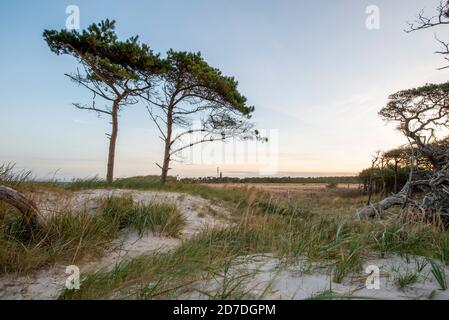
[142,50,262,183]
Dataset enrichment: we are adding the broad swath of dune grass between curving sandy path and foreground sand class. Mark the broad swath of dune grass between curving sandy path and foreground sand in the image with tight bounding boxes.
[61,189,447,299]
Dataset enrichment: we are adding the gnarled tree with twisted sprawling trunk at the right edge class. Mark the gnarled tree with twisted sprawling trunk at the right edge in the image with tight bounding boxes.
[358,82,449,219]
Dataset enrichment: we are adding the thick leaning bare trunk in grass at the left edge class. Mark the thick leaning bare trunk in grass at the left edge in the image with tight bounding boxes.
[0,185,43,225]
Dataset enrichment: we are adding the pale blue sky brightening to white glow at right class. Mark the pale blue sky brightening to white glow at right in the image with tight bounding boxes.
[0,0,447,178]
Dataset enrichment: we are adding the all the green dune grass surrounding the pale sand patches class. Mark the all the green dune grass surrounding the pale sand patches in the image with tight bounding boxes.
[0,169,449,299]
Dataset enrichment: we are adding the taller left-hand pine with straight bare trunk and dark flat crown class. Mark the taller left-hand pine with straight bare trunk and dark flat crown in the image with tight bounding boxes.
[43,20,162,183]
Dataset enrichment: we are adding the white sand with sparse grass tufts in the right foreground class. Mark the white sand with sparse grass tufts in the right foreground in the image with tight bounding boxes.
[182,255,449,300]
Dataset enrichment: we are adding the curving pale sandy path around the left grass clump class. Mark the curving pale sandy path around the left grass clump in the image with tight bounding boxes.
[0,190,227,300]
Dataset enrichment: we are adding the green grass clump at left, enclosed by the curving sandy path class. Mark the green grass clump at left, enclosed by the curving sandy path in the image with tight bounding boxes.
[0,198,185,274]
